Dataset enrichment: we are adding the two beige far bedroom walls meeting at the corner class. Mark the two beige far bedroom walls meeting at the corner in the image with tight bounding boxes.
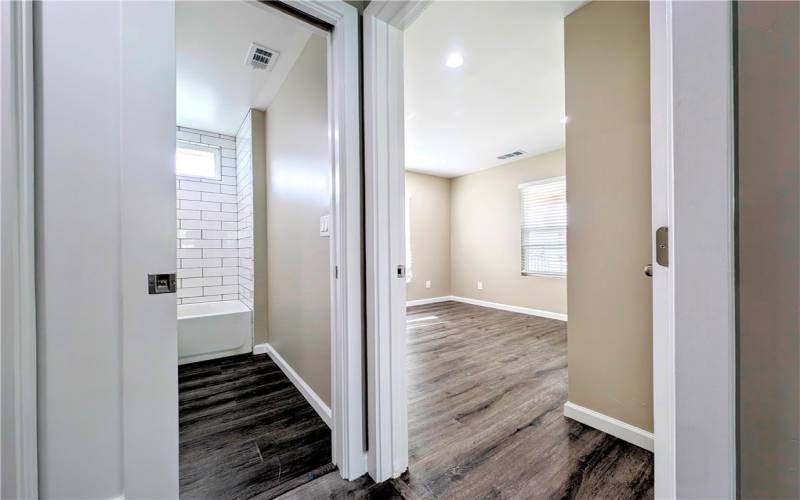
[406,150,567,314]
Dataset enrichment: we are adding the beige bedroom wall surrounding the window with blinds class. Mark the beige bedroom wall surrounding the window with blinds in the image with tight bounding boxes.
[450,150,567,313]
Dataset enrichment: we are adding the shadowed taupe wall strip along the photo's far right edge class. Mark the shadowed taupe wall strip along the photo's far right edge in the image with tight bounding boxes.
[737,2,800,499]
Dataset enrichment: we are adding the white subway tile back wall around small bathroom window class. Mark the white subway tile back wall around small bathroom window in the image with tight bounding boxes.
[176,127,239,304]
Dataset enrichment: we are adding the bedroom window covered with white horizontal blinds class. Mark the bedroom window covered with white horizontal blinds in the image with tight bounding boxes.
[519,177,567,276]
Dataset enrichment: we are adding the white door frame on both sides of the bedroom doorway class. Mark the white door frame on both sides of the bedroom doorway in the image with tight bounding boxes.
[364,0,735,498]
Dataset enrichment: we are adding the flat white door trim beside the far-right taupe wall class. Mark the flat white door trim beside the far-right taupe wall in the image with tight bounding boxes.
[668,1,736,498]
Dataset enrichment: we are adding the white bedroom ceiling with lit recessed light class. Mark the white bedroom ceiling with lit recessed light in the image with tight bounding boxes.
[405,1,585,177]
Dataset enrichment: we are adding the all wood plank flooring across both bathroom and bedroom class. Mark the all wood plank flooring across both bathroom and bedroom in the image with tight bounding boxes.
[180,302,653,500]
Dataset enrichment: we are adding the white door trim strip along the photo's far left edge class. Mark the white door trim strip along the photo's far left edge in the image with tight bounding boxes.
[0,2,39,498]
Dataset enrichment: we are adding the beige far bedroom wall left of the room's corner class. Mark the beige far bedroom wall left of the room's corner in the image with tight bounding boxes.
[406,172,450,300]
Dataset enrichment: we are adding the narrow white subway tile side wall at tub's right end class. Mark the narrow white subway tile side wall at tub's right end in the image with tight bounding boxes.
[236,112,253,309]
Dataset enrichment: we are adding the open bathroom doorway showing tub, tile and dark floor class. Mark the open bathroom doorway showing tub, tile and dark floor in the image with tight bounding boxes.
[175,2,337,498]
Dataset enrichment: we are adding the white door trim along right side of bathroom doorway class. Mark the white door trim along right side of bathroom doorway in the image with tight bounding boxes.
[278,0,367,479]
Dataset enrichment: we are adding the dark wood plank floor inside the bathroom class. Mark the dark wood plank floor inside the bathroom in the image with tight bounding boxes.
[178,354,336,499]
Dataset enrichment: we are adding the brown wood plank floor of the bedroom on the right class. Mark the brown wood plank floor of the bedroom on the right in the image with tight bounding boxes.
[395,302,653,499]
